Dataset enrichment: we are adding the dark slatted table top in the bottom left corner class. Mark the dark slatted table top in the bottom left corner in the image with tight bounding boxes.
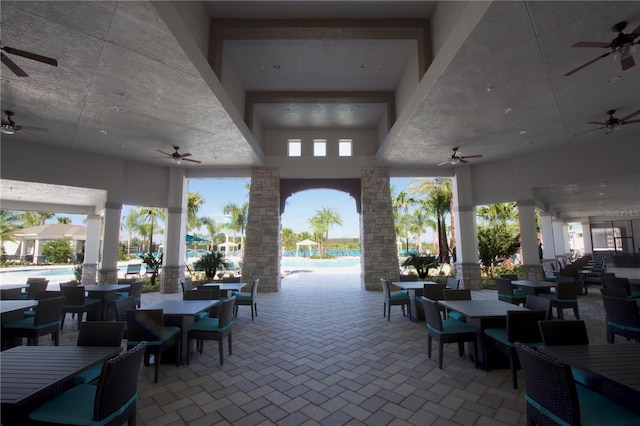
[0,346,121,406]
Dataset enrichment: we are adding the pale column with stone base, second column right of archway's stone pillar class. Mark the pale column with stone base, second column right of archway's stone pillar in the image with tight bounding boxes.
[517,200,544,281]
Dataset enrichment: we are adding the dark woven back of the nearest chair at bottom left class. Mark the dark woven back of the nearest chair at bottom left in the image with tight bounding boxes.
[93,342,146,423]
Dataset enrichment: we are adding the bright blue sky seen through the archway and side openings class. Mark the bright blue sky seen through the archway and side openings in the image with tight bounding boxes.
[61,178,412,238]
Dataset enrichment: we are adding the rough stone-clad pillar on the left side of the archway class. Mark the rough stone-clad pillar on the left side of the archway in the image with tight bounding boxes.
[242,167,281,292]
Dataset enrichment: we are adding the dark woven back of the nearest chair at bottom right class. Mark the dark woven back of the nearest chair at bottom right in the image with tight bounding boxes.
[516,343,581,425]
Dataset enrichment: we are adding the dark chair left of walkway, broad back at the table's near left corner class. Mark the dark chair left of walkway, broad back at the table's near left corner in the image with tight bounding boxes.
[127,309,181,383]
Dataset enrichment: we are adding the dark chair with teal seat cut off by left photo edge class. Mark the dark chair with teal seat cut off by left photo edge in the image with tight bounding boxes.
[2,297,64,346]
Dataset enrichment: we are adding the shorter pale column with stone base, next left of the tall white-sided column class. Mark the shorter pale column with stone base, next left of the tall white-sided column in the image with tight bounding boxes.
[98,202,122,284]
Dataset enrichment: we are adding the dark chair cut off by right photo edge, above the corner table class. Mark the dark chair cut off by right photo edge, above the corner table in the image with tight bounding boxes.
[602,296,640,343]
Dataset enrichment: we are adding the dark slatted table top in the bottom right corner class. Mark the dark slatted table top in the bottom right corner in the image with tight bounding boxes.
[538,343,640,393]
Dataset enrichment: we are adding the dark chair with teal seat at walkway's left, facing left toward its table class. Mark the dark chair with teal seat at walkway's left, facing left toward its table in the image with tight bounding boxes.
[187,296,236,365]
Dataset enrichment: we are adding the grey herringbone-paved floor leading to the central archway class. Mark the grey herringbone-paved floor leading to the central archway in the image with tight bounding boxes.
[48,271,637,426]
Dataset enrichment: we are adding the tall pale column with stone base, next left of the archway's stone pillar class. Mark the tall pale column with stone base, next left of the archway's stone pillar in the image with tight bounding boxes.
[160,167,187,293]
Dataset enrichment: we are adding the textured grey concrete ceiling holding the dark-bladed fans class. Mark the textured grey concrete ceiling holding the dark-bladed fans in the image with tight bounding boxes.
[0,1,640,223]
